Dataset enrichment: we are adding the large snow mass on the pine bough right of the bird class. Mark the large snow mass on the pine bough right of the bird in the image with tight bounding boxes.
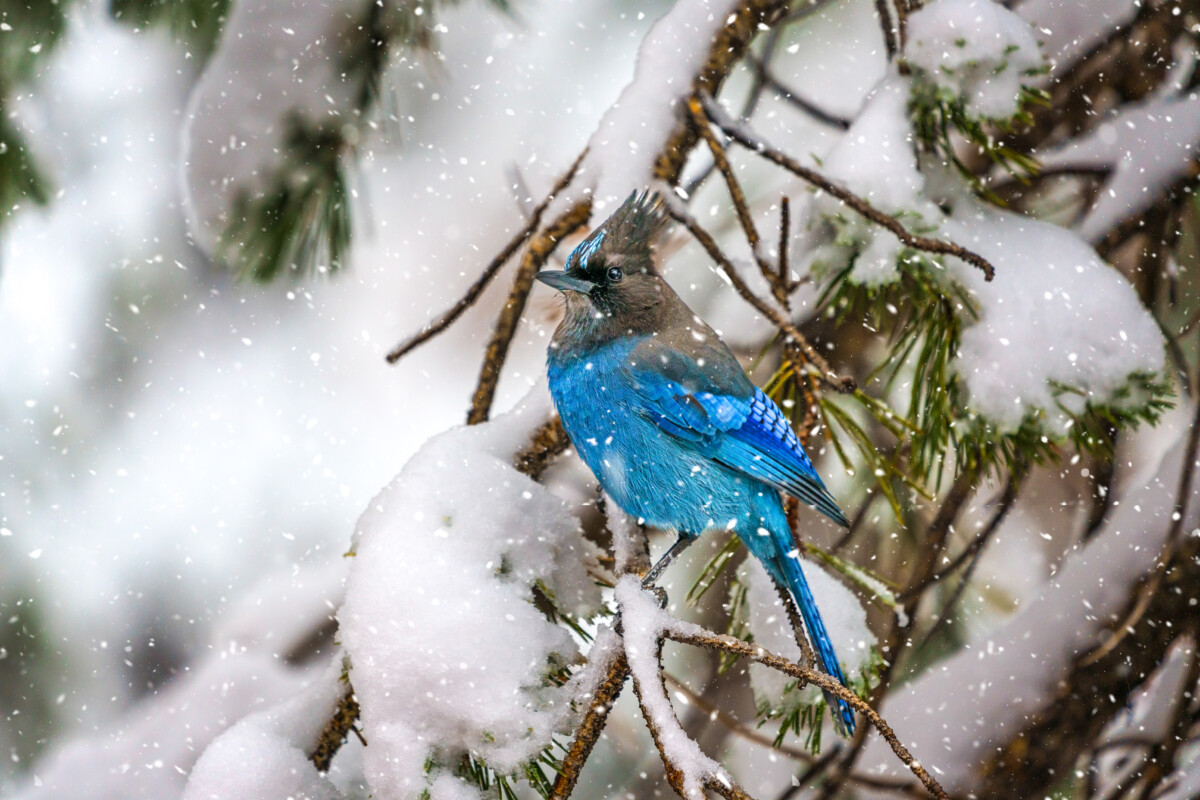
[805,65,1163,435]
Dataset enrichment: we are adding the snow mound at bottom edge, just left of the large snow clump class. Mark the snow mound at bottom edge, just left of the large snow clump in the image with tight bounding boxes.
[182,654,344,800]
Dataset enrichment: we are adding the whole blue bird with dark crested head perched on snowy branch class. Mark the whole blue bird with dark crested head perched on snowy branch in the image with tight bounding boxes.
[538,192,854,735]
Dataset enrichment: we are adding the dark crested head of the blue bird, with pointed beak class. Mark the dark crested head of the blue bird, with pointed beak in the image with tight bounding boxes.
[538,192,670,329]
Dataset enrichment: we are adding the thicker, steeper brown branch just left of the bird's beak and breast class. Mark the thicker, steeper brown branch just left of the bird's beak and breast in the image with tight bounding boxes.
[467,198,592,425]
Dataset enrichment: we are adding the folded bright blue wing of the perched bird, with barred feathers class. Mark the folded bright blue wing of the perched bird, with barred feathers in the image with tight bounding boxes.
[635,371,850,527]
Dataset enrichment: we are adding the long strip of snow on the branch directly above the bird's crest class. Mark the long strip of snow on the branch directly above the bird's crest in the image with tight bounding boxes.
[581,0,740,209]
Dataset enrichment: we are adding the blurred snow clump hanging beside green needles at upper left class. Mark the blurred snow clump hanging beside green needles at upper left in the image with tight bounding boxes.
[184,0,371,252]
